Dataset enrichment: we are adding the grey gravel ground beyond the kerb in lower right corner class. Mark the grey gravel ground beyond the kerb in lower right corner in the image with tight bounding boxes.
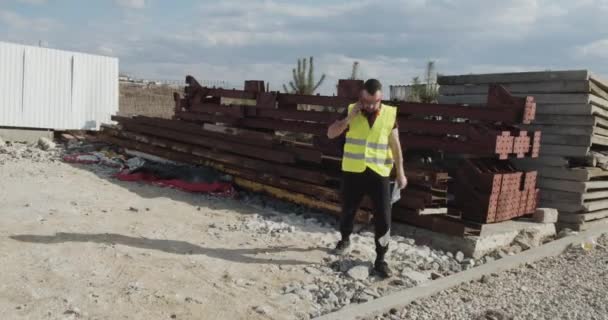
[375,235,608,320]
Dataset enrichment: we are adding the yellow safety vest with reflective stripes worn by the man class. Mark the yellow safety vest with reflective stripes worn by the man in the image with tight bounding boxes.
[342,103,397,177]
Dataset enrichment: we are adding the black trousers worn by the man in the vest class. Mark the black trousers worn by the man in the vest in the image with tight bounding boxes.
[340,168,391,261]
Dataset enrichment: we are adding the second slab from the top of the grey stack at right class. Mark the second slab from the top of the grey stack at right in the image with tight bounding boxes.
[439,80,592,96]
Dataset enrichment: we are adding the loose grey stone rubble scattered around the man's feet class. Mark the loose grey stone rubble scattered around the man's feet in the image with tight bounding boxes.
[214,201,544,317]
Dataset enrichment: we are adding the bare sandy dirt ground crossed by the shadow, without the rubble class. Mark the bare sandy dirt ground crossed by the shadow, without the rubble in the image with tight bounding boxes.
[0,160,337,319]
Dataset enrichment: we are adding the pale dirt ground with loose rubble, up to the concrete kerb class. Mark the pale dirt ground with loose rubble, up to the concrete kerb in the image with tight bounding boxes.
[0,143,474,319]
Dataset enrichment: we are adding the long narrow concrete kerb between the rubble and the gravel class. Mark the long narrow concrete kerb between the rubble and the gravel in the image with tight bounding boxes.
[317,219,608,320]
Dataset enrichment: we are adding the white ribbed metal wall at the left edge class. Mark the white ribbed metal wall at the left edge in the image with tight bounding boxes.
[0,42,119,130]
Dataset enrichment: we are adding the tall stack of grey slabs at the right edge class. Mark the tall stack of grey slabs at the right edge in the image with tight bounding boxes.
[438,70,608,230]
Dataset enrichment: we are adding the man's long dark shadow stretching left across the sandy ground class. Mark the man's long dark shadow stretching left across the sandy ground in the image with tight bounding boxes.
[10,232,329,265]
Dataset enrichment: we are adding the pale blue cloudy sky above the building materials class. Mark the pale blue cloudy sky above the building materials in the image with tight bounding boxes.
[0,0,608,93]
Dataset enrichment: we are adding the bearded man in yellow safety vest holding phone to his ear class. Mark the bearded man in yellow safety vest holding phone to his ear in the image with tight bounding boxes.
[327,79,407,278]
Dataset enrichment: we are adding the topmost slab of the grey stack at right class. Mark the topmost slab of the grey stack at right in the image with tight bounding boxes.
[437,70,590,85]
